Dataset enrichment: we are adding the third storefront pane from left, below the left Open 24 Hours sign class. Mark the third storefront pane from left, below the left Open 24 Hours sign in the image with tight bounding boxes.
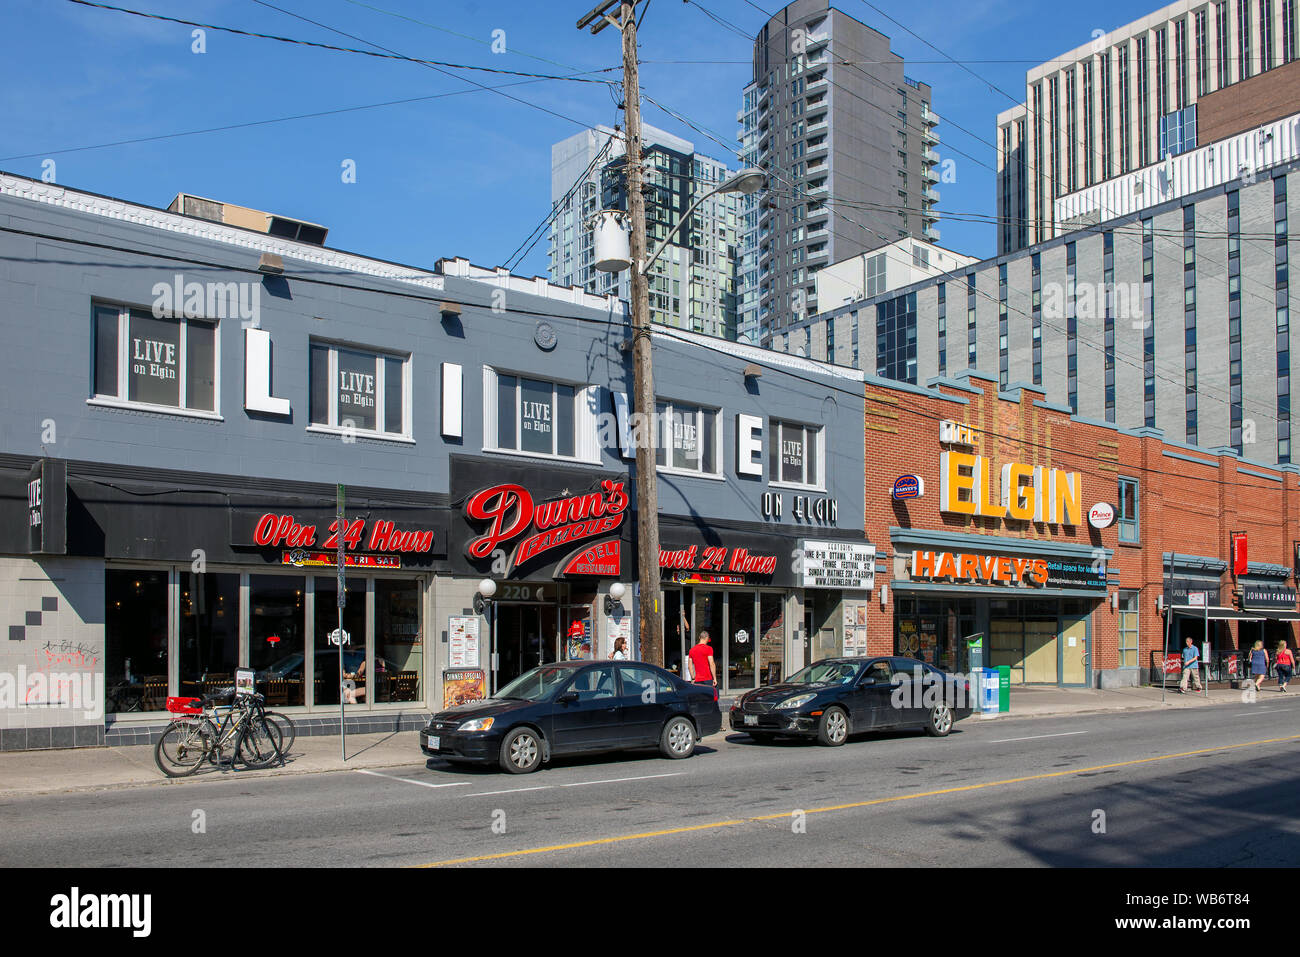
[248,575,307,707]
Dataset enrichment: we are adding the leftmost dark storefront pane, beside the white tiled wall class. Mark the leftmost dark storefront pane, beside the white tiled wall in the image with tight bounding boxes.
[104,570,168,714]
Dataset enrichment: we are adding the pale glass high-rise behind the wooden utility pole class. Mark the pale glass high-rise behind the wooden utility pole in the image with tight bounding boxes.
[549,126,741,339]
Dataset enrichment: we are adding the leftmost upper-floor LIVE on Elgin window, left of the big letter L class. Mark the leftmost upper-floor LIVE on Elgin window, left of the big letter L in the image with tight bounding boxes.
[92,303,218,412]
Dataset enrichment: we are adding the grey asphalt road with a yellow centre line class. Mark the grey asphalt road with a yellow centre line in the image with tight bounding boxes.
[0,696,1300,867]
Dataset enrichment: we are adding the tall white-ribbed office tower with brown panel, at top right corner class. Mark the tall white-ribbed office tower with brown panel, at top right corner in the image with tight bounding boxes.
[997,0,1300,254]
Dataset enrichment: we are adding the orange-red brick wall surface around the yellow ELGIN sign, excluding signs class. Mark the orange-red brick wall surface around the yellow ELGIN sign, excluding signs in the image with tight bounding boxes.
[865,373,1300,686]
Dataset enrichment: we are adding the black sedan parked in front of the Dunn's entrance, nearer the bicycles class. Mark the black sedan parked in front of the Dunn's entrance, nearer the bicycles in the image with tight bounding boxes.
[420,661,723,774]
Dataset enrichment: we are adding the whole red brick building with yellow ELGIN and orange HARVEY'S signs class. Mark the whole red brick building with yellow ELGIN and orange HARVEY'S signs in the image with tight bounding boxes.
[865,372,1300,687]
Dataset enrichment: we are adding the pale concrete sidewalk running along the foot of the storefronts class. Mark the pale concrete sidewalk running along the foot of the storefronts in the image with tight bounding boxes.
[0,687,1283,798]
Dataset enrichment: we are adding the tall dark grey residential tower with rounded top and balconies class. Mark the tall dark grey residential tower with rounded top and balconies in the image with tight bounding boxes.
[737,0,939,346]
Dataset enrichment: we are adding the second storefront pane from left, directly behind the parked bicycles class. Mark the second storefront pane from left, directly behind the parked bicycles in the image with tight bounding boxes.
[177,572,239,697]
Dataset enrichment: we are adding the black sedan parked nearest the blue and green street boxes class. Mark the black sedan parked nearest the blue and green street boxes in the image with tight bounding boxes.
[731,658,972,748]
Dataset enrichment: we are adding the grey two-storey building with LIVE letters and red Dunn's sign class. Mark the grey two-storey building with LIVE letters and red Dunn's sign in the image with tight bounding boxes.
[0,174,871,749]
